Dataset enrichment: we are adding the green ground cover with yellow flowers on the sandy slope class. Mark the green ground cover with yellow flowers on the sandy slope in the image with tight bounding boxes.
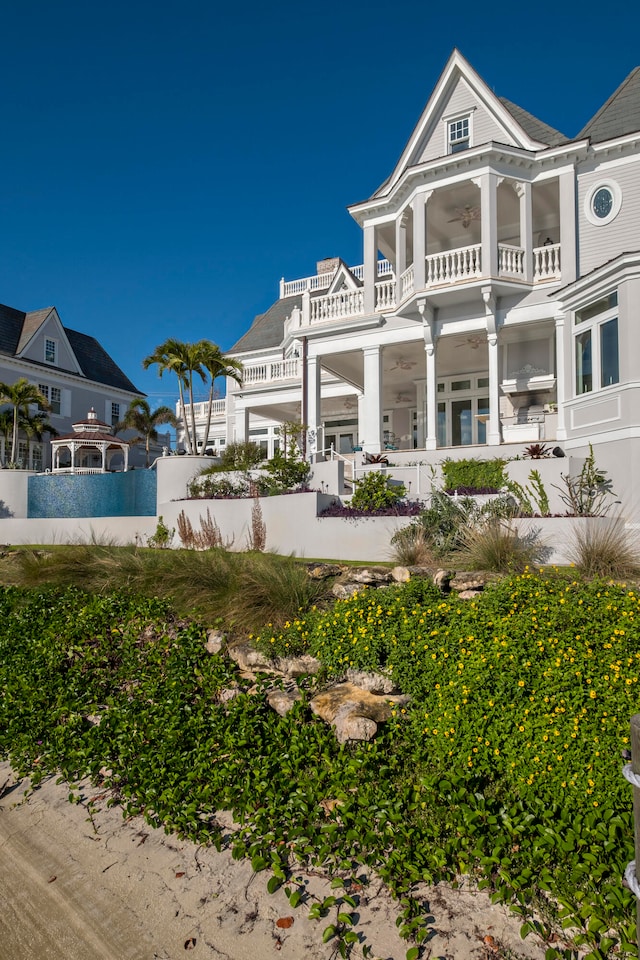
[0,560,640,960]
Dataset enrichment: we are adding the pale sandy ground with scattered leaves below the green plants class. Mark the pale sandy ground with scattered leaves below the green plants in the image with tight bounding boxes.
[0,763,544,960]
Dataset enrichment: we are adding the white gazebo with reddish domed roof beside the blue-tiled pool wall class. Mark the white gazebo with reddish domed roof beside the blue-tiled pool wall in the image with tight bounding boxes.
[51,407,129,473]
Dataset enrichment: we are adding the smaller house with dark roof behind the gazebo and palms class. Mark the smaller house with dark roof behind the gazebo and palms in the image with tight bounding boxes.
[0,305,161,470]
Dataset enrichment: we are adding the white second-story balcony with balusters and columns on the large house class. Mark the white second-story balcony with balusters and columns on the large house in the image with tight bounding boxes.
[280,167,575,332]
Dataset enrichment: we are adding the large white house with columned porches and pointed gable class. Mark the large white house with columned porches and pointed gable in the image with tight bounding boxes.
[181,50,640,506]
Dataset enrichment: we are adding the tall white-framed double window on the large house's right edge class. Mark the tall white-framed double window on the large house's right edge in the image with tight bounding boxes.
[575,292,620,396]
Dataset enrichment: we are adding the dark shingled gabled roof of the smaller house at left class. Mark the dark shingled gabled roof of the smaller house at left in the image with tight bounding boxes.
[0,296,144,396]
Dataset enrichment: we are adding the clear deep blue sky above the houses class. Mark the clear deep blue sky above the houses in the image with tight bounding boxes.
[0,0,640,405]
